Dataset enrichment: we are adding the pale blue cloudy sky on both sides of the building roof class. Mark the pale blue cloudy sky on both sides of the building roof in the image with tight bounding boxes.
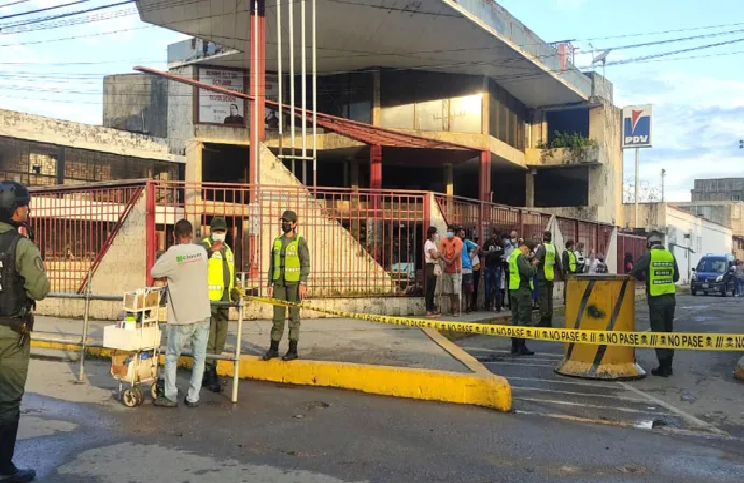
[0,0,744,201]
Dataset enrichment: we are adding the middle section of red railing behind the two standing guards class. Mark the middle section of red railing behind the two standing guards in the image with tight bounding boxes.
[153,182,428,297]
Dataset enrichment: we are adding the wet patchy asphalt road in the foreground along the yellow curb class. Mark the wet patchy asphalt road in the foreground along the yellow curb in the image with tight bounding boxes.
[17,298,744,483]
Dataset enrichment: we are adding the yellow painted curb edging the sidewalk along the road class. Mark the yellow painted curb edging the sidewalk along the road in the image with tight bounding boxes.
[31,340,512,411]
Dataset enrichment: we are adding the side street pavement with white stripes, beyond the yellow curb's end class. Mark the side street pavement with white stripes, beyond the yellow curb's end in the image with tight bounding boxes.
[459,295,744,437]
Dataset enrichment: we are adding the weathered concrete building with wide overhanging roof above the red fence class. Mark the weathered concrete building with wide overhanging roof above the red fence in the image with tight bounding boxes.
[112,0,623,224]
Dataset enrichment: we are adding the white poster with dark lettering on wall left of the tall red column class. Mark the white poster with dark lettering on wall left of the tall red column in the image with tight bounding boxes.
[199,67,245,126]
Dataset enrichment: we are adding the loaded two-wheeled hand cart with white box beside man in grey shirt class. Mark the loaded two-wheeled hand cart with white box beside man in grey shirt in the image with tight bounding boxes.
[103,287,161,407]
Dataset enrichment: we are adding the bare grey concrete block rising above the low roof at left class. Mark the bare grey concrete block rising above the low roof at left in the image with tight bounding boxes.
[103,74,168,138]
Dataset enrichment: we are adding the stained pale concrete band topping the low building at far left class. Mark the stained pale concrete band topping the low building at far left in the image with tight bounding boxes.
[0,110,174,161]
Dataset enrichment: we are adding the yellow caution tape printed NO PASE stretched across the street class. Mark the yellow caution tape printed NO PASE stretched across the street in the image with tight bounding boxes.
[246,297,744,351]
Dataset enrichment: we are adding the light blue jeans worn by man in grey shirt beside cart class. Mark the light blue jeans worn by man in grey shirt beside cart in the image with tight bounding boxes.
[165,317,209,402]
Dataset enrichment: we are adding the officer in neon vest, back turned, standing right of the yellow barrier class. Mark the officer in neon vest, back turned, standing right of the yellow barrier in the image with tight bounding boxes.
[630,233,679,377]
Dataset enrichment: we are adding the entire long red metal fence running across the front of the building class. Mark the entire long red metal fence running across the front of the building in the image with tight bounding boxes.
[31,180,632,297]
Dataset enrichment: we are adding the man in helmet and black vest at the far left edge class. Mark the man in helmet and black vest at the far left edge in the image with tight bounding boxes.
[0,182,49,483]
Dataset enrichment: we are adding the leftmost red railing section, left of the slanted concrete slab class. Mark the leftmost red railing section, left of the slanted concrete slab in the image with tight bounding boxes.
[30,180,145,292]
